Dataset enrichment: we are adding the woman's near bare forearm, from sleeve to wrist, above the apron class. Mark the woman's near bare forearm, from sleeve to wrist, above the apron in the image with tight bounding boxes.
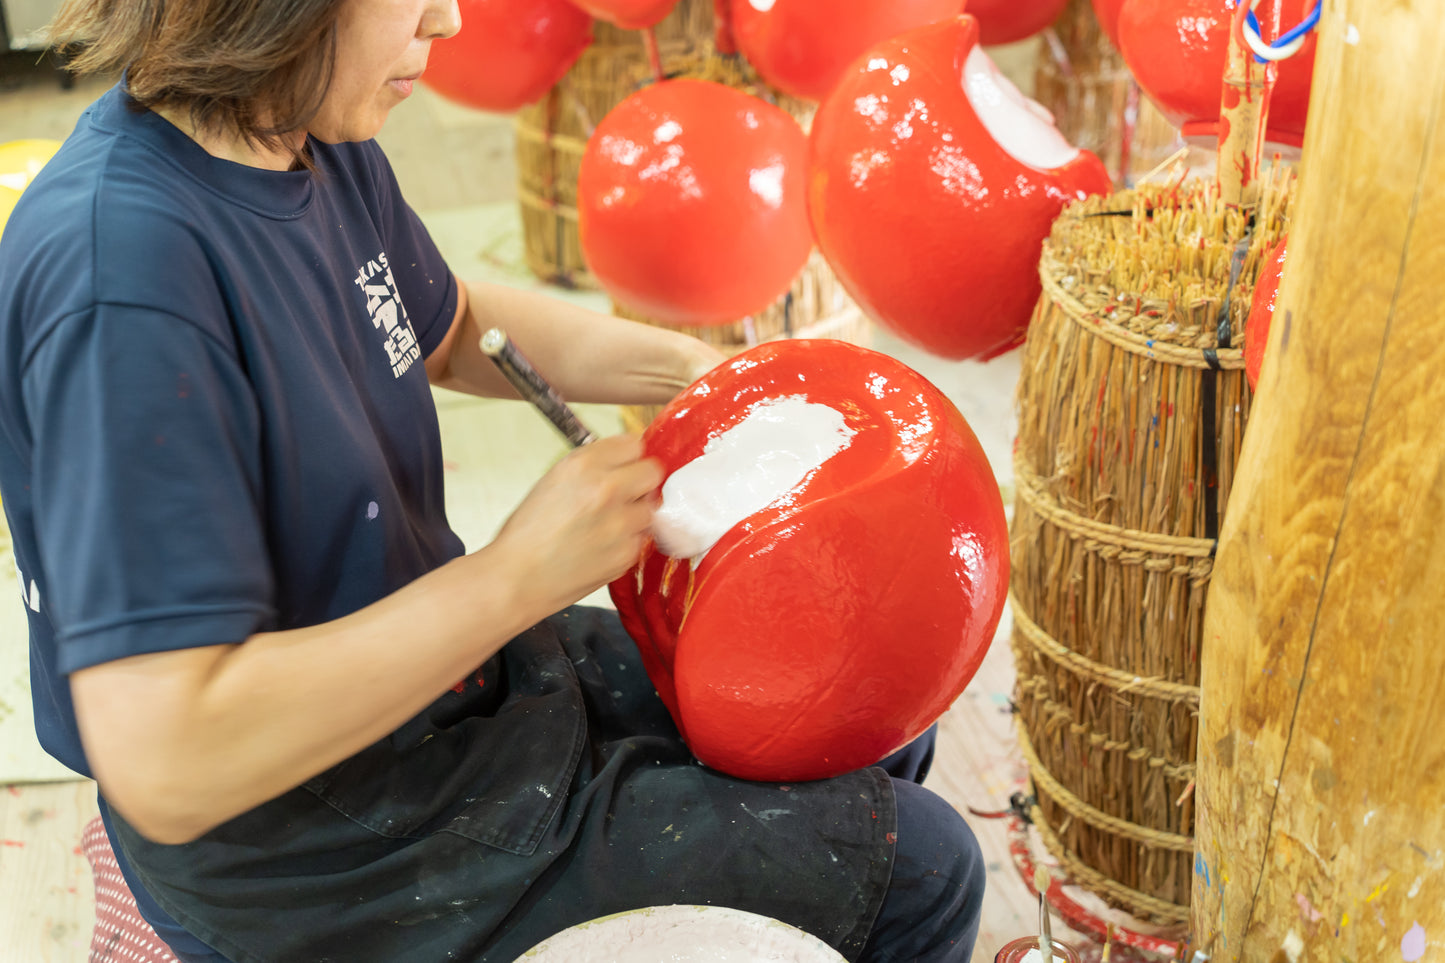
[71,540,549,843]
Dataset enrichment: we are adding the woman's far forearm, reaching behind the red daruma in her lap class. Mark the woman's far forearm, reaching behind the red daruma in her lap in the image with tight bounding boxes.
[436,283,724,405]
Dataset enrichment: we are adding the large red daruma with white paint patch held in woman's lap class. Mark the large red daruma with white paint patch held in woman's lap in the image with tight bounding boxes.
[611,340,1009,781]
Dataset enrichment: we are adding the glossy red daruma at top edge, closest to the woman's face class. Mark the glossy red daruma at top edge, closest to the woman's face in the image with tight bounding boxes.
[422,0,592,113]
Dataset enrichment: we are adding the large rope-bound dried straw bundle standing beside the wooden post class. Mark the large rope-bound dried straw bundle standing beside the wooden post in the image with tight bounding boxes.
[1012,166,1293,924]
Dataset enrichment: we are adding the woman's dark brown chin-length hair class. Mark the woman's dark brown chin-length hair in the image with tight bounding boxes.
[51,0,342,166]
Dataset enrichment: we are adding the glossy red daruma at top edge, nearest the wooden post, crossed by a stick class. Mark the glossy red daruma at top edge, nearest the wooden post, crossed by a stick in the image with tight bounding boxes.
[1117,0,1315,146]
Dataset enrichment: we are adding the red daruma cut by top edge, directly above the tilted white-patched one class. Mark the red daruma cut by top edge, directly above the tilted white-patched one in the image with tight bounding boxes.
[731,0,964,100]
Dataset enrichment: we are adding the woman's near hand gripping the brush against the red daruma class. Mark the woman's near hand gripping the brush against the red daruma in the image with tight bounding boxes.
[491,435,663,612]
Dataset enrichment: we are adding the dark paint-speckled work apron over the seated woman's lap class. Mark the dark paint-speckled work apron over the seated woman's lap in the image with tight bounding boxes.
[113,607,896,963]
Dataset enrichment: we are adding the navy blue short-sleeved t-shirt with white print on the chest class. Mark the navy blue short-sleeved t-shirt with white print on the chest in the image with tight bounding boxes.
[0,87,462,954]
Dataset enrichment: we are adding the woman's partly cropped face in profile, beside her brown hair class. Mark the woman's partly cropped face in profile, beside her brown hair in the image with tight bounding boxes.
[308,0,461,143]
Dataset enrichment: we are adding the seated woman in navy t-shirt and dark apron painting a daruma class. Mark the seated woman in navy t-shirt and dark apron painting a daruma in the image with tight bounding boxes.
[0,0,983,962]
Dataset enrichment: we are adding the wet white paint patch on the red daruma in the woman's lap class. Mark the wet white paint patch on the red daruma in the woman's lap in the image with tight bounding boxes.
[652,395,855,561]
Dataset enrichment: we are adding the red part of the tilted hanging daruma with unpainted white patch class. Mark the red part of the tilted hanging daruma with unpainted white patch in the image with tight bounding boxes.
[808,14,1111,359]
